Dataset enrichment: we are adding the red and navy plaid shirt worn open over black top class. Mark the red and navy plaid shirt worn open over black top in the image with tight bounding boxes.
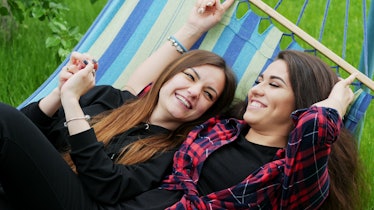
[161,107,342,209]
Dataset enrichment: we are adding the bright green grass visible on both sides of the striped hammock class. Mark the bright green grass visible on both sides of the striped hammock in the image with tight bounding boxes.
[0,0,374,209]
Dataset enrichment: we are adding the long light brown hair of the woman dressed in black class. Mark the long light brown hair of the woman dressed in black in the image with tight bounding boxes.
[63,50,236,169]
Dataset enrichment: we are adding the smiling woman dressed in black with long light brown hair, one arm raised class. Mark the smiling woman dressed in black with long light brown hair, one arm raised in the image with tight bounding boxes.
[0,0,236,210]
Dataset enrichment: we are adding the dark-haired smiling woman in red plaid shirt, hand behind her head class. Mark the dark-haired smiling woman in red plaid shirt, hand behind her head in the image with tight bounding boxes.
[117,50,364,209]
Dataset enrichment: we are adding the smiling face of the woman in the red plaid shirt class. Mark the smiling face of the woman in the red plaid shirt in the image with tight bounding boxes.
[243,60,295,131]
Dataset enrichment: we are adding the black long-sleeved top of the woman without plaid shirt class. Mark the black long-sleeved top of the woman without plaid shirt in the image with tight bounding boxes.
[21,86,175,204]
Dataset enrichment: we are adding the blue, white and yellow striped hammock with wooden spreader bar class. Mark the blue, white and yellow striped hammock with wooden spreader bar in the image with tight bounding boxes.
[18,0,374,139]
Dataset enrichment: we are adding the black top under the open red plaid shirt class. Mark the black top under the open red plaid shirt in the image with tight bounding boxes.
[197,135,279,195]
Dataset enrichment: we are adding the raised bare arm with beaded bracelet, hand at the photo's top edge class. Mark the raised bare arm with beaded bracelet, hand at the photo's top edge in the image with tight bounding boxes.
[124,0,234,95]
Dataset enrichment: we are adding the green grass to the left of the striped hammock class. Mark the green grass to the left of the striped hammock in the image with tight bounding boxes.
[0,0,106,106]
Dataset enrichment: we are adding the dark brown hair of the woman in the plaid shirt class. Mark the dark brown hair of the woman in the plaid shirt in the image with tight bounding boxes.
[227,50,364,209]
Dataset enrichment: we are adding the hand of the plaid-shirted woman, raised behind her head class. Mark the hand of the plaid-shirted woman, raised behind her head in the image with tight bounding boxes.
[315,74,356,118]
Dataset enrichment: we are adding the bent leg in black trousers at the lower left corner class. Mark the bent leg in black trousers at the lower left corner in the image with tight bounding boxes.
[0,103,96,210]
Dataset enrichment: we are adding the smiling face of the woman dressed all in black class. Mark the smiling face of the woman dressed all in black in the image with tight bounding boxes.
[155,65,225,124]
